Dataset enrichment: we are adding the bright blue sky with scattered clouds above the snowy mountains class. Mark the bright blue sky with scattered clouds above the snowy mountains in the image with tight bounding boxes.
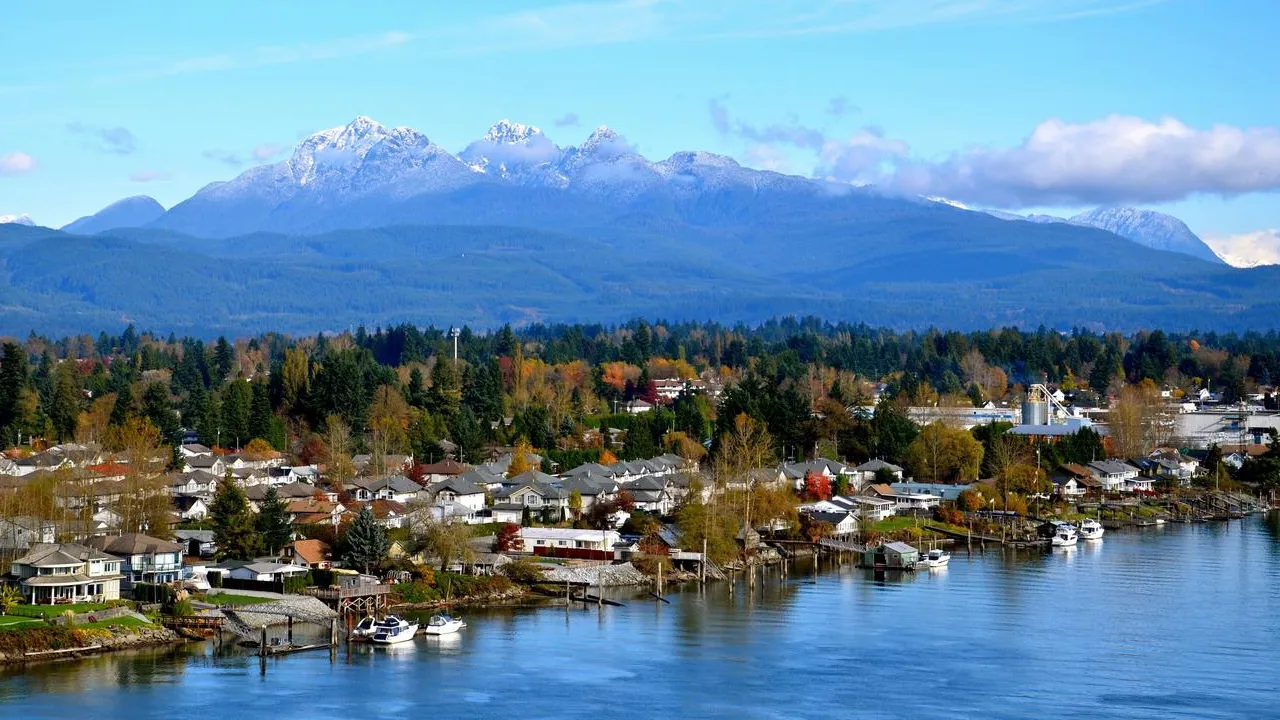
[0,0,1280,261]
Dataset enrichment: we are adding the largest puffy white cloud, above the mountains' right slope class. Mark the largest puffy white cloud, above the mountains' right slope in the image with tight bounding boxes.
[882,115,1280,208]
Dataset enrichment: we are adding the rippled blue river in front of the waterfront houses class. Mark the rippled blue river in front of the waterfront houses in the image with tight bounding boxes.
[0,514,1280,720]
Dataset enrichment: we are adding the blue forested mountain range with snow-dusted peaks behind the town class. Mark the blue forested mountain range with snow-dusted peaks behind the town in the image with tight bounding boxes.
[0,118,1280,334]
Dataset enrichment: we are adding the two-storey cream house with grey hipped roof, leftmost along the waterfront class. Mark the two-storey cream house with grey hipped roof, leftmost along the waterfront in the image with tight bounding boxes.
[9,543,122,605]
